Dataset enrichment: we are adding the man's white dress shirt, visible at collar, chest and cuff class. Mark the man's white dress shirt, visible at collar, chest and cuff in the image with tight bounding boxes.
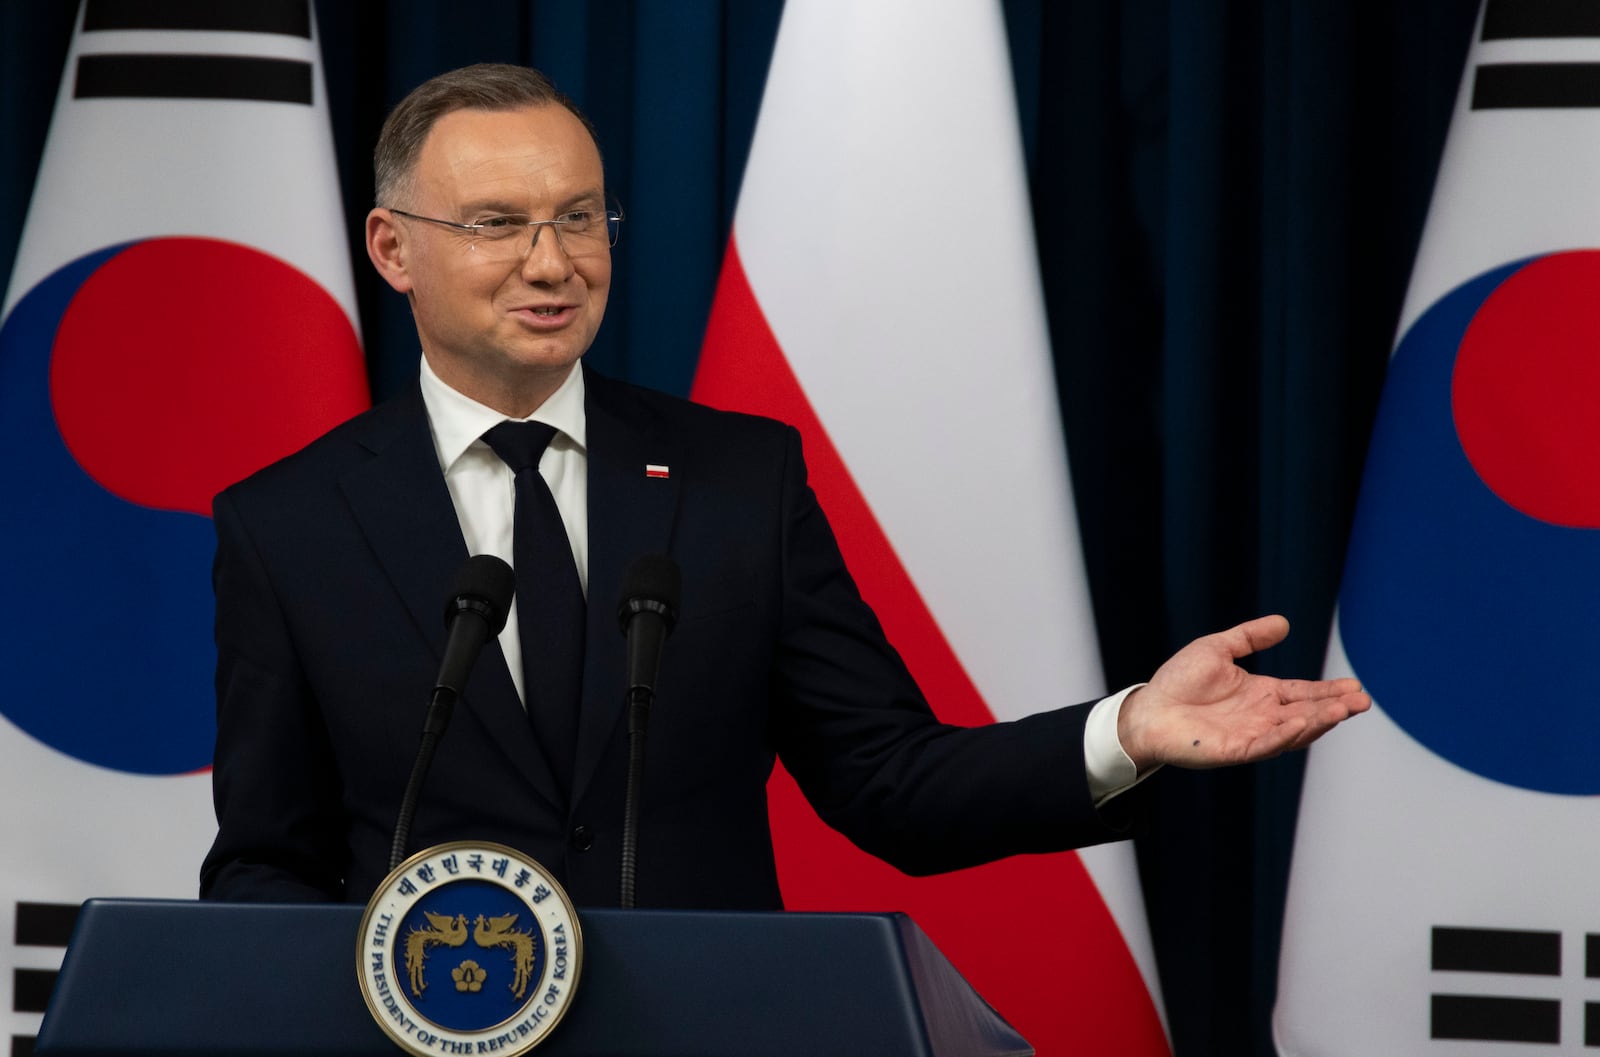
[421,357,1141,804]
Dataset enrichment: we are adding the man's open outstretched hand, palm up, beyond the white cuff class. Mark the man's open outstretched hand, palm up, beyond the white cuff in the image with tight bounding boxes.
[1117,616,1373,774]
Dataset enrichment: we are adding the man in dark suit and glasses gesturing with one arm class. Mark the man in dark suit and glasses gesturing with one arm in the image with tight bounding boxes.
[202,67,1368,908]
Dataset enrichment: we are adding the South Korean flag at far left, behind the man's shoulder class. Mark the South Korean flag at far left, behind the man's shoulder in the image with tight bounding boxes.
[0,0,366,1047]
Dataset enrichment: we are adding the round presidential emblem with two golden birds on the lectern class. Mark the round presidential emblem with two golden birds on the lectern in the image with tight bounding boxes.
[357,841,582,1057]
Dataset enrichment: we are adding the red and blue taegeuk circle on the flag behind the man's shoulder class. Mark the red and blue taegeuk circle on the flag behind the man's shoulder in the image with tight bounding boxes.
[0,238,368,774]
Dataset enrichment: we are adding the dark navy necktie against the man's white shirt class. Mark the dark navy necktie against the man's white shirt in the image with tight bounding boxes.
[483,422,586,793]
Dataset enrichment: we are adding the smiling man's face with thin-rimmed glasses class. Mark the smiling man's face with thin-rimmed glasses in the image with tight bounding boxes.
[374,106,611,416]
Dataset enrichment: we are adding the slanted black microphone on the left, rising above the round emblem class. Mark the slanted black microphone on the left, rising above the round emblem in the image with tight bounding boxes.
[389,555,517,870]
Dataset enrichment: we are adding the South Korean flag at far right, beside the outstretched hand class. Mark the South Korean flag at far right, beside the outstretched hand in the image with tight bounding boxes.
[1274,2,1600,1057]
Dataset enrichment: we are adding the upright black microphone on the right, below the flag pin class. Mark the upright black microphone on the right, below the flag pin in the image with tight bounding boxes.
[616,555,683,908]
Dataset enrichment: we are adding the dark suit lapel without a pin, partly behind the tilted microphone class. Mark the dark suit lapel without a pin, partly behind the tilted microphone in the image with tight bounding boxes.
[341,392,563,804]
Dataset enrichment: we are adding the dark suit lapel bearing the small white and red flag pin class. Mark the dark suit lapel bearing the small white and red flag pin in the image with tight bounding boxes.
[573,371,683,803]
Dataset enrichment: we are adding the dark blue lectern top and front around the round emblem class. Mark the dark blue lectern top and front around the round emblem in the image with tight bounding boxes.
[37,900,1034,1057]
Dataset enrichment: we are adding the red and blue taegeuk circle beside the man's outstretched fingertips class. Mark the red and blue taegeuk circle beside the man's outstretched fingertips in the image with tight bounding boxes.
[1339,249,1600,795]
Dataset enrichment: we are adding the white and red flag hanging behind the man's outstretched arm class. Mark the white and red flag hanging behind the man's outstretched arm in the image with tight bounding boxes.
[694,0,1170,1055]
